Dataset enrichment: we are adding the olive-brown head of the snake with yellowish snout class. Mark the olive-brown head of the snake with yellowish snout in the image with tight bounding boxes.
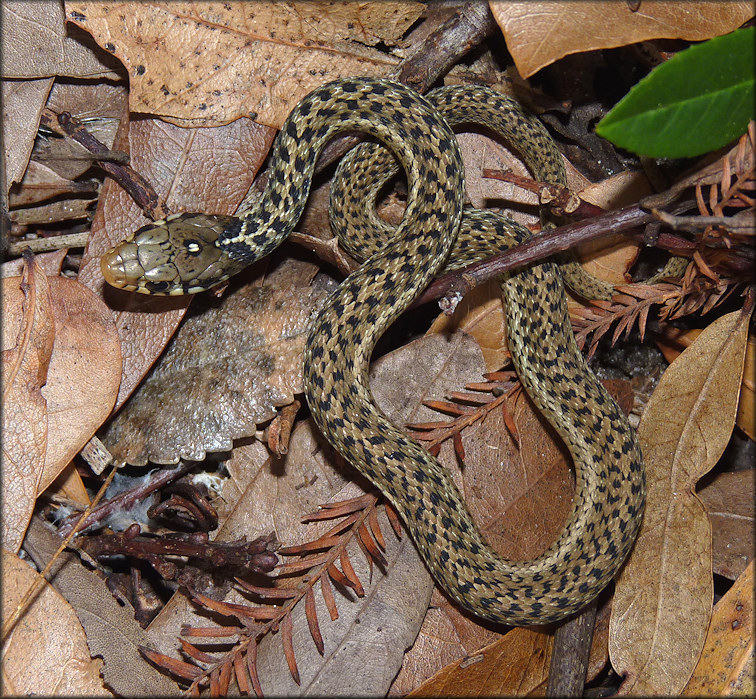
[100,214,247,296]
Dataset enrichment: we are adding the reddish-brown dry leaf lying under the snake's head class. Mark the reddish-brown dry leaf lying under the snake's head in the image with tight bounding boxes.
[79,109,275,409]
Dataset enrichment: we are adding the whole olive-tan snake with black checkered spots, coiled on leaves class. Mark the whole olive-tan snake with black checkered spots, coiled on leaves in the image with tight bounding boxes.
[102,78,644,624]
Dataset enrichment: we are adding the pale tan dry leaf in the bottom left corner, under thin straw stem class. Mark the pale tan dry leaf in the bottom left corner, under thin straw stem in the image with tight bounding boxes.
[1,550,113,697]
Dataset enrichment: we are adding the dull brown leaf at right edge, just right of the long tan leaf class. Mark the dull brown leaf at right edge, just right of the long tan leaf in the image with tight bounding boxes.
[698,474,756,580]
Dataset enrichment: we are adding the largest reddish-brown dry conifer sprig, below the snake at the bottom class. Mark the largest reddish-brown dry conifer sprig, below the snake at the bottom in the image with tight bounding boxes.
[140,494,401,696]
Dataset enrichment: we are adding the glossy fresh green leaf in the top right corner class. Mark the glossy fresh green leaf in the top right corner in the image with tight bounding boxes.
[596,27,756,158]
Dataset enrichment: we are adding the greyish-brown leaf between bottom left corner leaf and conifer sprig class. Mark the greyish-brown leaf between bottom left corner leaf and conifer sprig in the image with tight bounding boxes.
[24,517,179,697]
